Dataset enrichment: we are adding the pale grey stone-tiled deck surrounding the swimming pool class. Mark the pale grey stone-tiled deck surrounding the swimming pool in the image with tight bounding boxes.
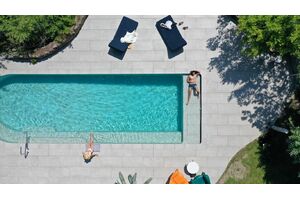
[0,16,259,183]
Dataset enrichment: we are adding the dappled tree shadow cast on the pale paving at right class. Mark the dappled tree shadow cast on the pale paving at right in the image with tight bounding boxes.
[207,16,292,131]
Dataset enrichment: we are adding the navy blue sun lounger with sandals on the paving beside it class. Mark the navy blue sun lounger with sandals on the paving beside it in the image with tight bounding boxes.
[155,15,187,51]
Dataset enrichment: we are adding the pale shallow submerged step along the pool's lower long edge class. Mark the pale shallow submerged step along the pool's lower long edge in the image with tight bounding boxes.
[0,124,182,144]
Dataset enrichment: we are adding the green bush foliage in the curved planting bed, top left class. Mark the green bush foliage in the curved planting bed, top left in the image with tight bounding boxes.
[0,15,75,55]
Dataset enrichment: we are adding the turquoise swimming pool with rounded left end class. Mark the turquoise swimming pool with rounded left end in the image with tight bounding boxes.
[0,74,183,143]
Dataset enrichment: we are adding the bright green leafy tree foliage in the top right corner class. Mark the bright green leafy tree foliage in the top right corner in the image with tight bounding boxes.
[238,15,300,59]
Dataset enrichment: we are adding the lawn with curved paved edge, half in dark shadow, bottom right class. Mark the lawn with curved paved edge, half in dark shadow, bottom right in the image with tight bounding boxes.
[218,135,300,184]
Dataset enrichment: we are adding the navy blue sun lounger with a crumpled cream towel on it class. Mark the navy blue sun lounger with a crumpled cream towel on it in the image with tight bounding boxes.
[108,16,138,52]
